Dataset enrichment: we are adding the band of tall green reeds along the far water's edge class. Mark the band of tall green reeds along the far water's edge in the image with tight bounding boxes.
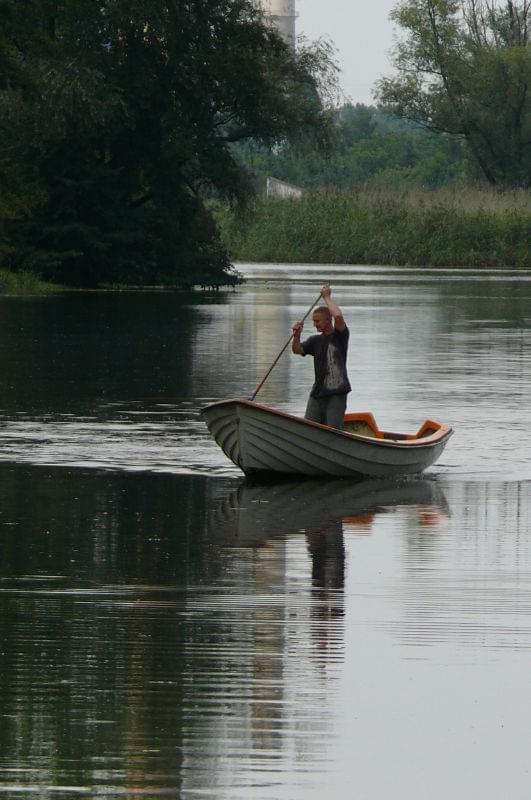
[216,190,531,268]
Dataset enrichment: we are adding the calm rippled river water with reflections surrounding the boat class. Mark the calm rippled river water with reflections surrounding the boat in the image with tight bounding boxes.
[0,265,531,800]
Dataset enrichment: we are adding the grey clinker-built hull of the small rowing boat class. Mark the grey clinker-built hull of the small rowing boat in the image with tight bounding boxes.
[201,398,452,478]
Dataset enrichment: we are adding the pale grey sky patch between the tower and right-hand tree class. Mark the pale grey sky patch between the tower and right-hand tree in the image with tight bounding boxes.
[295,0,398,105]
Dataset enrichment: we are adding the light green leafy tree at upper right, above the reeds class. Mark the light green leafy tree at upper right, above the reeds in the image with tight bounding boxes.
[378,0,531,187]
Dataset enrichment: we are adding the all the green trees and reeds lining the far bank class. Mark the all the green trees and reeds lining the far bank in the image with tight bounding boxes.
[4,0,531,294]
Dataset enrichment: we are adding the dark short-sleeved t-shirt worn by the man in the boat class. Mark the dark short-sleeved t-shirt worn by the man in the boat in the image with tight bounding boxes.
[301,327,350,397]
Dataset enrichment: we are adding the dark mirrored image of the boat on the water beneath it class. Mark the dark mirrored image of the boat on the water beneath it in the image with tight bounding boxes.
[209,479,448,547]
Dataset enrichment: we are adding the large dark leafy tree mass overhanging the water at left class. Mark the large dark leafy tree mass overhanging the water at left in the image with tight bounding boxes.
[0,0,331,286]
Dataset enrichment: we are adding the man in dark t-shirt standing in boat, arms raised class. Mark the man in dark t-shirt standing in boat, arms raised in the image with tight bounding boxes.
[291,285,350,430]
